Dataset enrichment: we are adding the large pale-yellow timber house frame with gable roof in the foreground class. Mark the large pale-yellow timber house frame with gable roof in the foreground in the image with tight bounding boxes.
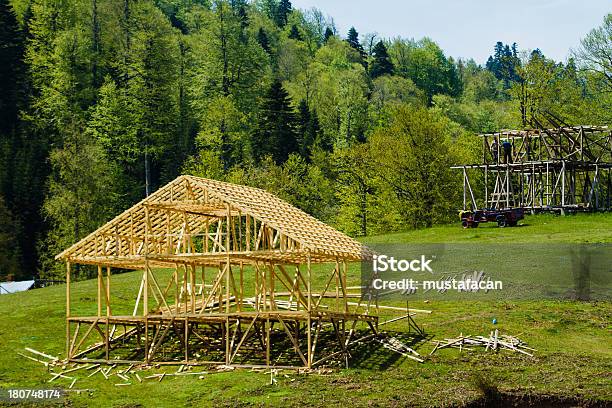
[56,176,378,368]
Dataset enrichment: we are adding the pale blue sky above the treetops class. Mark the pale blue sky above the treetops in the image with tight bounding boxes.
[291,0,612,64]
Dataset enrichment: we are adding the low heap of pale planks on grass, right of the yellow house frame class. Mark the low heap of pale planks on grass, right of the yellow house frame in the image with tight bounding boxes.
[429,329,537,357]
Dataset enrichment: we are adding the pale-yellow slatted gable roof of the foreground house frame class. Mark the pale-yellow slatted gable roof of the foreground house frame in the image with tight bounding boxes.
[56,175,370,263]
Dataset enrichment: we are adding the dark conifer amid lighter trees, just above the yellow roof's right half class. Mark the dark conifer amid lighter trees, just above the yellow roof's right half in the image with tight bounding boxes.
[251,80,298,164]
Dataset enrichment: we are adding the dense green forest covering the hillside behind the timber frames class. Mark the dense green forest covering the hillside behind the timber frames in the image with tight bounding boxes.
[0,0,612,280]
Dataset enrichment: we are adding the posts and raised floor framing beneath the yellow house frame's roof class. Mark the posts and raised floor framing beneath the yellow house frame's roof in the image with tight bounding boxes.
[66,261,378,368]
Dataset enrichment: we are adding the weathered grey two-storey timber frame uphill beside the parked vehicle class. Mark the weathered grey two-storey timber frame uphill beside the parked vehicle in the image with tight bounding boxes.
[452,126,612,214]
